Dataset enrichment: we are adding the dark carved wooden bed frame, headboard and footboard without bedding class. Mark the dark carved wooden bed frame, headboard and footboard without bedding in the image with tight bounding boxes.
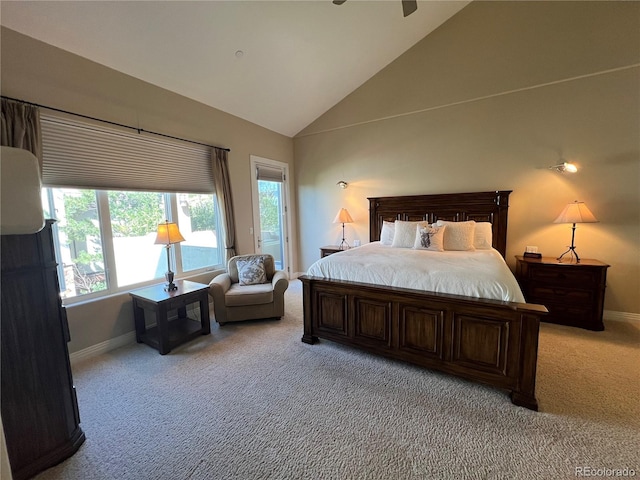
[300,191,547,410]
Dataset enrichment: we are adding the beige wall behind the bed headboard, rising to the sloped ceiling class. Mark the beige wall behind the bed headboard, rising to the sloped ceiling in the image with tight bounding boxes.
[294,1,640,314]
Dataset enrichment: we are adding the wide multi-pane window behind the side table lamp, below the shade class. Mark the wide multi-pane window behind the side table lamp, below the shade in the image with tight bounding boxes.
[42,188,224,303]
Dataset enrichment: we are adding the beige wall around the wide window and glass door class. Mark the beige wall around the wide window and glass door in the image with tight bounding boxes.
[1,28,297,352]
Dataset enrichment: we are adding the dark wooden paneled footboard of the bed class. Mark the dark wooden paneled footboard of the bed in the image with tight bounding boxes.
[300,276,547,410]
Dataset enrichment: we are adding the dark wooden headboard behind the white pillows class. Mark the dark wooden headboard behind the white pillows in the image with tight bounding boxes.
[368,190,511,257]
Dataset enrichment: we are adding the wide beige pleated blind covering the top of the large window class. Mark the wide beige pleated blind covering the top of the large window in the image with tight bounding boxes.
[40,114,215,193]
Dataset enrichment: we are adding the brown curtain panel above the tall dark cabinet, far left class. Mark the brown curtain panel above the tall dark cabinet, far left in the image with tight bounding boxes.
[0,98,42,173]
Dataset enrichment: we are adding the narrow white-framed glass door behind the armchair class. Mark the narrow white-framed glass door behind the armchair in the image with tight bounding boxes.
[251,155,291,274]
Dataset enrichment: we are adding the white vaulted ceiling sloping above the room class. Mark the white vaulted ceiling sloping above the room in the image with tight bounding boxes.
[0,0,469,136]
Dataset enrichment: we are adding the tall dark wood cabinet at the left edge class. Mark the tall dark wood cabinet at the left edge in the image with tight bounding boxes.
[0,220,85,480]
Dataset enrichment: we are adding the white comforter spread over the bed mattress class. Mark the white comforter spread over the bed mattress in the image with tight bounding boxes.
[307,242,525,303]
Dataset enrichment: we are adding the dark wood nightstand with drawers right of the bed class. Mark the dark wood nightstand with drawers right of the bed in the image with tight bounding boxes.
[516,255,609,330]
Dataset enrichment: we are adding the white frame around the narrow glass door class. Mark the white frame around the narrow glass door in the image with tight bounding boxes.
[249,155,292,277]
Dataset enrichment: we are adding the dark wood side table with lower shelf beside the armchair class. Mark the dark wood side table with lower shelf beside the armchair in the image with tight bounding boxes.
[129,280,211,355]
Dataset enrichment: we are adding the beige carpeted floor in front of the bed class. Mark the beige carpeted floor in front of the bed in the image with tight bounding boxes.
[36,281,640,480]
